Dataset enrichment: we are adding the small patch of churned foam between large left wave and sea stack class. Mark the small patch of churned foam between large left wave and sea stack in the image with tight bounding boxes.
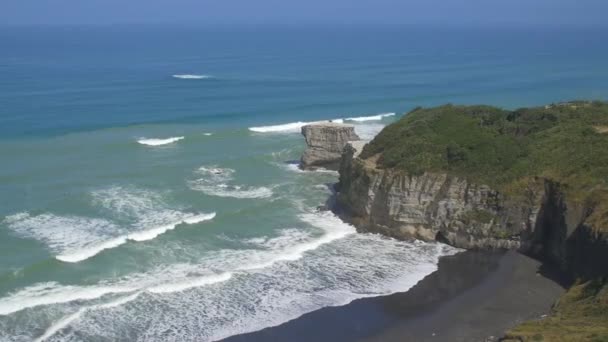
[188,166,274,199]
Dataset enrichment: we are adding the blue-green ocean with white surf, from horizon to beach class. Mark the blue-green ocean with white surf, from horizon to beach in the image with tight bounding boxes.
[0,27,608,341]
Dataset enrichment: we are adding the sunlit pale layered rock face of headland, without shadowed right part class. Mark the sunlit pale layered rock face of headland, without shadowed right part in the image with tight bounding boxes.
[337,146,544,249]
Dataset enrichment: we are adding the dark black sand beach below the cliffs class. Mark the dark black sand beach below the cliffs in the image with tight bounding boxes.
[224,251,563,342]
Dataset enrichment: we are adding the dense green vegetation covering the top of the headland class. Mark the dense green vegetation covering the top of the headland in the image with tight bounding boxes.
[361,101,608,230]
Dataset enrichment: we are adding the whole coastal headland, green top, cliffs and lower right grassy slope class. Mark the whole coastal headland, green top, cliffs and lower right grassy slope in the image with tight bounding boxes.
[335,101,608,341]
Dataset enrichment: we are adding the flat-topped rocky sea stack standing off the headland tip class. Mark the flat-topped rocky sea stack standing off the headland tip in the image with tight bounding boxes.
[301,122,360,170]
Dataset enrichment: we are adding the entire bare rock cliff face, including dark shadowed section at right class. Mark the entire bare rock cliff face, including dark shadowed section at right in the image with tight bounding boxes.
[335,144,608,273]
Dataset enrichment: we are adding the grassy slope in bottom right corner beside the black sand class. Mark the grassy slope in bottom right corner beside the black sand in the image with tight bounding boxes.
[505,280,608,342]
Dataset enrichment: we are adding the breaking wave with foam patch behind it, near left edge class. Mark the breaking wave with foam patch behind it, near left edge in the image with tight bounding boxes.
[4,187,215,263]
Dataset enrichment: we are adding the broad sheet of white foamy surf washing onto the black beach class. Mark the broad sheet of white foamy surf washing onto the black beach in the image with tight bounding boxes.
[0,212,458,341]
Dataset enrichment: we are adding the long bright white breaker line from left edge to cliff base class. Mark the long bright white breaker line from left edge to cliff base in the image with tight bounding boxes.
[0,212,355,318]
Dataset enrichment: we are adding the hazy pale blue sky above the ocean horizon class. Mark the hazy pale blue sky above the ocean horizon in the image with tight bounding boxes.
[0,0,608,27]
